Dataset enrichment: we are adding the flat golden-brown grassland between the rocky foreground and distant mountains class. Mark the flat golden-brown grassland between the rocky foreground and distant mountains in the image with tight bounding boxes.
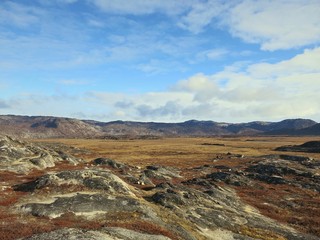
[30,137,320,168]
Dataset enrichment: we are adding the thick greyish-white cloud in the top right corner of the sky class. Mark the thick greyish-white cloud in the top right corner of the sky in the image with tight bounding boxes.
[222,0,320,50]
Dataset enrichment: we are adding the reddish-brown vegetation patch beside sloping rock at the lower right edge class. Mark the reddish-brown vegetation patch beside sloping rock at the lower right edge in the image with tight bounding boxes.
[236,183,320,236]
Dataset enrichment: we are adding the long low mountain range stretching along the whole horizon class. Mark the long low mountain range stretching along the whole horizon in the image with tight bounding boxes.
[0,115,320,138]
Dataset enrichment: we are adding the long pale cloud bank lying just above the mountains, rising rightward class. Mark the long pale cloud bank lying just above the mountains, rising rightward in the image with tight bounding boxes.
[1,48,320,122]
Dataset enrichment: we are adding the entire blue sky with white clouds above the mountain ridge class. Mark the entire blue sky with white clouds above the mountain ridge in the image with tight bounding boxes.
[0,0,320,123]
